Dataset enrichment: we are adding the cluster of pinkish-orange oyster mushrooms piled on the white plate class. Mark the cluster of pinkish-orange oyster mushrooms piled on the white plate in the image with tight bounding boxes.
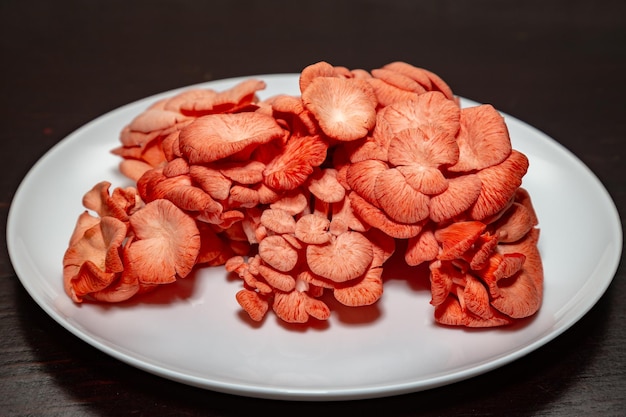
[63,62,543,327]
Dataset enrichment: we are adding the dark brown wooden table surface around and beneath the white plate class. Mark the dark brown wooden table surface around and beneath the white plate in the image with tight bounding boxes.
[0,0,626,416]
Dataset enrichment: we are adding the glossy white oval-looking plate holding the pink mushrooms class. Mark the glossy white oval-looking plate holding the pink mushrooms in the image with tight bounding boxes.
[7,74,622,400]
